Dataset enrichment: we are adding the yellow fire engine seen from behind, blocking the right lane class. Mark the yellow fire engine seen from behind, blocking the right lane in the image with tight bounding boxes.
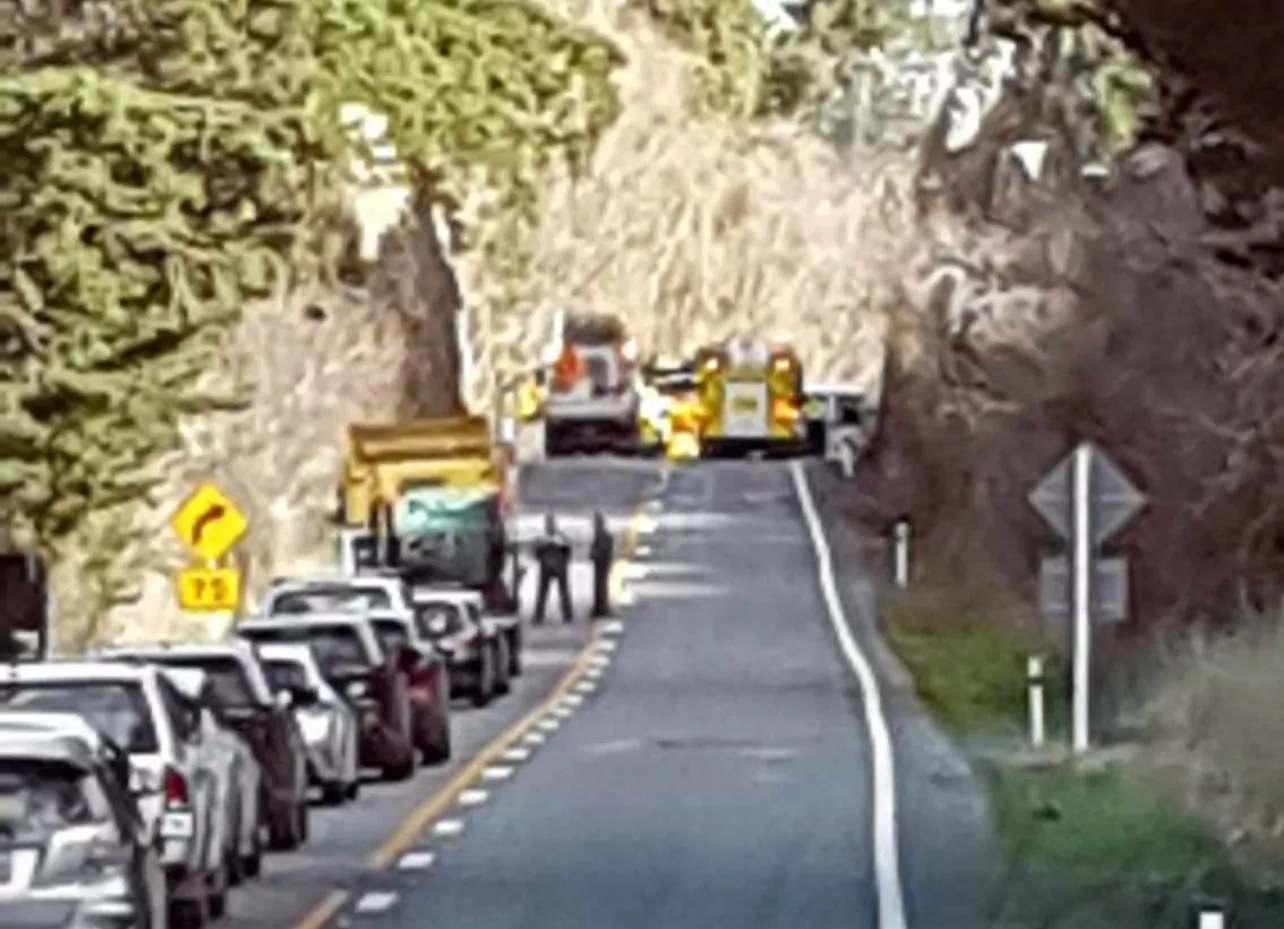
[696,340,808,457]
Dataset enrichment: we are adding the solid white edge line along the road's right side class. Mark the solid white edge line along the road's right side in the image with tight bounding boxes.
[790,462,905,929]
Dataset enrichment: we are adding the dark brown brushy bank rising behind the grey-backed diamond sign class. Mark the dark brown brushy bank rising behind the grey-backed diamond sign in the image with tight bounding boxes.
[869,1,1284,631]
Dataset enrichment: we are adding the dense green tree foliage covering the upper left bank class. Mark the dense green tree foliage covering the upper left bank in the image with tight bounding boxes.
[0,0,620,544]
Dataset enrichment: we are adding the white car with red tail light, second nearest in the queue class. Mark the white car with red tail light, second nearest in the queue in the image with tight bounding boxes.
[0,661,235,924]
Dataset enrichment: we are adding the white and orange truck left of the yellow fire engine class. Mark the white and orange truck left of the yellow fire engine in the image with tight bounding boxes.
[543,313,639,457]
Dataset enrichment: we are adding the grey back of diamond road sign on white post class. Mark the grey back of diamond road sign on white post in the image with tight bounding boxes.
[1030,441,1145,753]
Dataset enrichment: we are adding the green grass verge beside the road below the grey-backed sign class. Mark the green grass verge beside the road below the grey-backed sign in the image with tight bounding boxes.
[882,590,1284,929]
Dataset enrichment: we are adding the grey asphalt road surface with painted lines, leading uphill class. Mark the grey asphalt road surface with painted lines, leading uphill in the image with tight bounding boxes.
[231,461,991,929]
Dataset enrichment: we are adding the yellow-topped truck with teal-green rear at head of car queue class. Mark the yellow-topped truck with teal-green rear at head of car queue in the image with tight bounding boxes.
[340,416,515,597]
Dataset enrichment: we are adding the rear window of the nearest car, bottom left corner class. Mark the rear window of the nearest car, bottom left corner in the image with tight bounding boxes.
[0,758,107,843]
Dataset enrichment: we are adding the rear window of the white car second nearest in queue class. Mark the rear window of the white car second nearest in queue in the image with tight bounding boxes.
[0,680,161,754]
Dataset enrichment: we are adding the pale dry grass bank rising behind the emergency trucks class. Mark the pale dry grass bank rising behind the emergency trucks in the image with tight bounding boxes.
[467,10,908,395]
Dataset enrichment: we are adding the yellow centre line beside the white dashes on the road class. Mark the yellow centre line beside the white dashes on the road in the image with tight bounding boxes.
[294,507,642,929]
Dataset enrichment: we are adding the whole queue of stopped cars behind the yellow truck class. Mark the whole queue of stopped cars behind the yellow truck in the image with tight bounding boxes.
[0,572,523,929]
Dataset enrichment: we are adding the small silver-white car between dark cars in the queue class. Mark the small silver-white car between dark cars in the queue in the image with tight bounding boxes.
[258,643,361,803]
